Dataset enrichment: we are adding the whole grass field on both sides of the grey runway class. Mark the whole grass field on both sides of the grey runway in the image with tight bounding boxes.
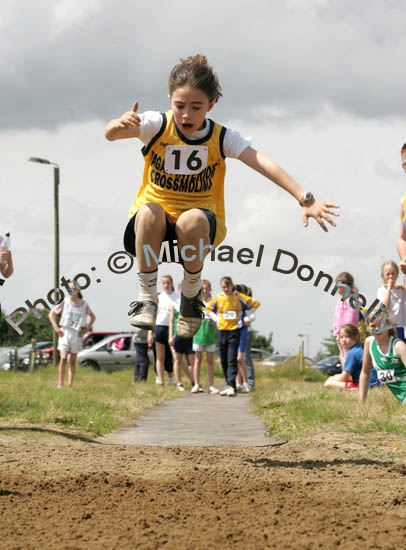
[0,363,406,448]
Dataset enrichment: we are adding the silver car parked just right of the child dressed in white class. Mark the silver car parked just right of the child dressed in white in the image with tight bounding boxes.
[77,332,154,372]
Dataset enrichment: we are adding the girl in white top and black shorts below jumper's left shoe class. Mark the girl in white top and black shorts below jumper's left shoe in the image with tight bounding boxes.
[154,275,179,386]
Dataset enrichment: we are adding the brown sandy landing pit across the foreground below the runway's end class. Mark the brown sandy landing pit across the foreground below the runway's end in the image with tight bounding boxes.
[0,429,406,550]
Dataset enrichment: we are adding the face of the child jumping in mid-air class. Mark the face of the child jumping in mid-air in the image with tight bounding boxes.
[170,84,215,136]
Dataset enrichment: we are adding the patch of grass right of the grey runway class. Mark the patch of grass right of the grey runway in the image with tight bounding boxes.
[251,363,406,446]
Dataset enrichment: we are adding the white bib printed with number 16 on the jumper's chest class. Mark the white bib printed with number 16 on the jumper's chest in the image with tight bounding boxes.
[165,145,208,174]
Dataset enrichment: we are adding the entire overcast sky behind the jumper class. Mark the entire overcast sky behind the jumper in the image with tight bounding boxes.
[0,0,406,355]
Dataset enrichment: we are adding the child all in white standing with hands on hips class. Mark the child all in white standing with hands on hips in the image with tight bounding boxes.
[49,282,96,388]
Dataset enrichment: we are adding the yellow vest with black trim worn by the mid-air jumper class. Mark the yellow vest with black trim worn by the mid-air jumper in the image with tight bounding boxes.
[129,110,227,246]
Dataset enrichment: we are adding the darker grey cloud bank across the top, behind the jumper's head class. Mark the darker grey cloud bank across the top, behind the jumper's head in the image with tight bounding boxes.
[0,0,406,130]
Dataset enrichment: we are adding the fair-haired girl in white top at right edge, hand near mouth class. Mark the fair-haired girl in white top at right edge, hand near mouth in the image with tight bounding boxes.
[377,260,406,342]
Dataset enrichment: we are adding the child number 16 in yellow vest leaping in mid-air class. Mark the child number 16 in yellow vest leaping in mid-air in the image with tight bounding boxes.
[105,55,338,338]
